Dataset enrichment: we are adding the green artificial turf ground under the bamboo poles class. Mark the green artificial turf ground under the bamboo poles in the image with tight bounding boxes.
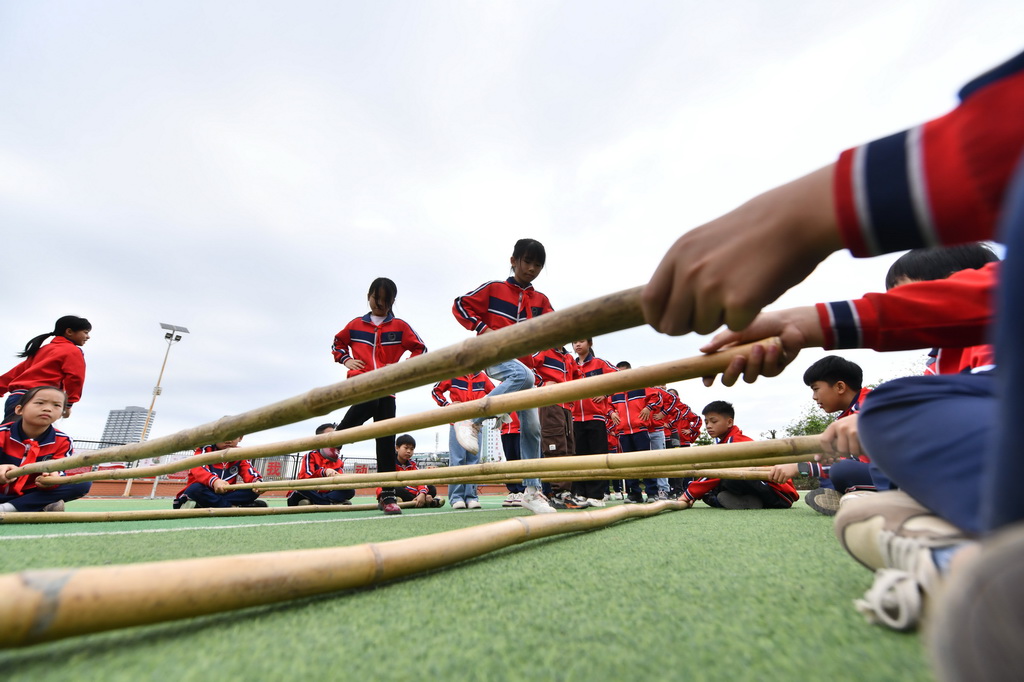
[0,499,931,681]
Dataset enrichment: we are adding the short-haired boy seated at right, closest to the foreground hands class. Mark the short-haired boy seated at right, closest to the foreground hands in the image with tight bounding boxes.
[771,355,876,516]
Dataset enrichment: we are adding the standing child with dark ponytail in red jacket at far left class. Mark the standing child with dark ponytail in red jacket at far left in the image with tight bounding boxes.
[0,315,92,424]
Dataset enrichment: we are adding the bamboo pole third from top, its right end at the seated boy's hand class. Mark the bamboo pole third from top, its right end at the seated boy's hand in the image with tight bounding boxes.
[235,435,821,491]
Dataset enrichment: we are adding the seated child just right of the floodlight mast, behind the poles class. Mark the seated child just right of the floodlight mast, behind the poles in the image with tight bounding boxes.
[171,436,266,509]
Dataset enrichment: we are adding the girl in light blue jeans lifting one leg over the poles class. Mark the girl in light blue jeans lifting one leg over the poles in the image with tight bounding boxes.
[452,239,555,514]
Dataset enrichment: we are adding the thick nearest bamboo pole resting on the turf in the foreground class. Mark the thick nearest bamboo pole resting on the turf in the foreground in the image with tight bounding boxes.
[0,502,685,647]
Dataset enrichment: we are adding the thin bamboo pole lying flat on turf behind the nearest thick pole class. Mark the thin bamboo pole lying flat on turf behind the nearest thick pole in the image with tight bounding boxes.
[0,502,416,525]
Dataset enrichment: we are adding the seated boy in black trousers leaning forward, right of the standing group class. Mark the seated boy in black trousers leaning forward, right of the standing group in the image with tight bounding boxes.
[679,400,800,509]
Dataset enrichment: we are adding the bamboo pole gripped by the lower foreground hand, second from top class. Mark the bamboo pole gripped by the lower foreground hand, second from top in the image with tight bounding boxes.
[28,339,778,485]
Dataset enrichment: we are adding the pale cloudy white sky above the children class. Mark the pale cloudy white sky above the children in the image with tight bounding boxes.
[0,0,1024,456]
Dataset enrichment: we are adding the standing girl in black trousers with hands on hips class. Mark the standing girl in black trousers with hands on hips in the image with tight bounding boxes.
[332,278,427,514]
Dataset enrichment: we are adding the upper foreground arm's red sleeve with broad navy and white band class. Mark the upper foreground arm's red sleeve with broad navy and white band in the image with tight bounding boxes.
[834,53,1024,256]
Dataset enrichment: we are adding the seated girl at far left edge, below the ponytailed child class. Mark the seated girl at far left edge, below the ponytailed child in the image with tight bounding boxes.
[0,386,92,512]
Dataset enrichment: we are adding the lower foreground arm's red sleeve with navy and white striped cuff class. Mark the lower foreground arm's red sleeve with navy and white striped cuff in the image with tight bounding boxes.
[816,263,999,350]
